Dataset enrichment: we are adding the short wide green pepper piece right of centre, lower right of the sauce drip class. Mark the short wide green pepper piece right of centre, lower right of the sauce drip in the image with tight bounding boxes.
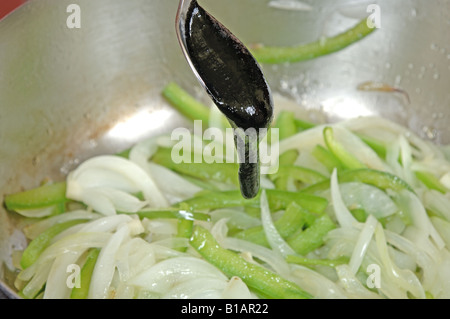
[287,214,336,256]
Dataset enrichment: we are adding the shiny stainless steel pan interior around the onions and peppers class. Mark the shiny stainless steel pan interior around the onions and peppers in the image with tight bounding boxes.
[0,0,450,297]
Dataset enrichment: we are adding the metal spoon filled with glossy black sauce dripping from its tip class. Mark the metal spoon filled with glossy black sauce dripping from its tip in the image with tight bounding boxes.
[176,0,273,198]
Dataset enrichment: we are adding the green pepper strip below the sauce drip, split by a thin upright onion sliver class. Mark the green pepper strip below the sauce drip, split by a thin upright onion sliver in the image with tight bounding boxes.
[235,203,318,248]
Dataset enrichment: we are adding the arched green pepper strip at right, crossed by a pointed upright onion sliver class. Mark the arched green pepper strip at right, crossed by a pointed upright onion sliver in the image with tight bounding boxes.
[300,168,414,194]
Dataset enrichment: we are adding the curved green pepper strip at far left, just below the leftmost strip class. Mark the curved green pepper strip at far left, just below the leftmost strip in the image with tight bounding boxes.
[20,219,87,269]
